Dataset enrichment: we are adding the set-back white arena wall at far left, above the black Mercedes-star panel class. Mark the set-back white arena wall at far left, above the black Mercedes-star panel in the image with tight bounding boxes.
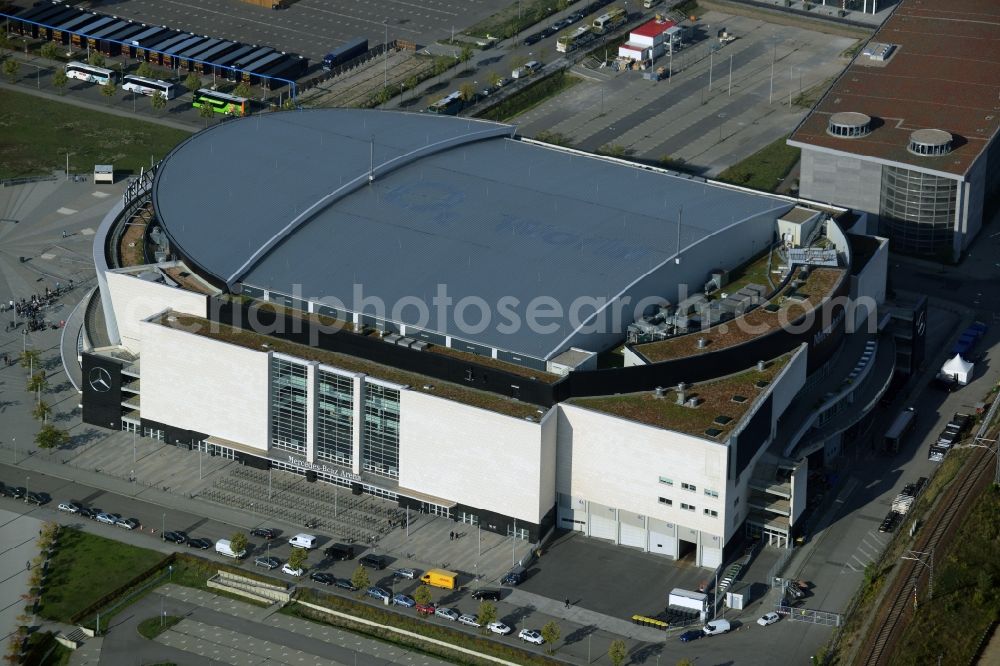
[105,271,208,352]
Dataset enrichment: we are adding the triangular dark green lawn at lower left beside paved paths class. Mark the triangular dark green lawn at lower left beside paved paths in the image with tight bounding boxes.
[38,529,164,622]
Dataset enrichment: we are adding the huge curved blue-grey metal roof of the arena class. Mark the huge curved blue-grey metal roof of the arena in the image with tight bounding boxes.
[153,109,793,359]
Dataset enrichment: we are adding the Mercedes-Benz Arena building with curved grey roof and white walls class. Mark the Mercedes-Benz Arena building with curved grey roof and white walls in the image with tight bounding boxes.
[82,110,885,567]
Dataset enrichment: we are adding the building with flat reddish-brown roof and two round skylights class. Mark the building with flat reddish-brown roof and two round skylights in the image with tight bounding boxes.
[788,0,1000,260]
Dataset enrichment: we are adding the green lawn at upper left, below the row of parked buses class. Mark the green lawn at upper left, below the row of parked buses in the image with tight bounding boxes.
[0,90,190,178]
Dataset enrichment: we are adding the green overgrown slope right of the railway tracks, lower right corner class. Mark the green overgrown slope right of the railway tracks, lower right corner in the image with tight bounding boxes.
[893,482,1000,664]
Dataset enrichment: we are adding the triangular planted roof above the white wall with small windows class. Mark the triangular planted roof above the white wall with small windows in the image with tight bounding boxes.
[569,352,795,442]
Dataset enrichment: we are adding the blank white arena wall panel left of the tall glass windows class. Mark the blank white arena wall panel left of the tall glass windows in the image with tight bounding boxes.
[139,322,270,454]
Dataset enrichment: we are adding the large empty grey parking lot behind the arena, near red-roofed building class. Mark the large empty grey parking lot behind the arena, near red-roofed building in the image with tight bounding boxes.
[515,11,855,176]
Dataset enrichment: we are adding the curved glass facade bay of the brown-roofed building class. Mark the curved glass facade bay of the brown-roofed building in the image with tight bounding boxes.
[879,166,958,255]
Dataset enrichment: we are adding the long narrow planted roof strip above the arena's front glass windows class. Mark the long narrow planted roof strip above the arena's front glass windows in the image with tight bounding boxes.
[151,311,543,420]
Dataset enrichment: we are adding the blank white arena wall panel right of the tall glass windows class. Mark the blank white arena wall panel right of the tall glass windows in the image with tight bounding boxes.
[399,391,555,524]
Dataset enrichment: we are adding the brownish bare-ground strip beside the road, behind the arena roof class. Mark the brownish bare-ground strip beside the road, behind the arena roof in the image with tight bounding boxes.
[301,50,434,107]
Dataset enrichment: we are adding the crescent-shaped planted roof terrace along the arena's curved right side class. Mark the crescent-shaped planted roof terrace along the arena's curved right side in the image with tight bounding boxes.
[635,268,844,363]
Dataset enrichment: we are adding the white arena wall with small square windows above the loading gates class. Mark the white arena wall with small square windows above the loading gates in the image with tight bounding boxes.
[556,403,728,538]
